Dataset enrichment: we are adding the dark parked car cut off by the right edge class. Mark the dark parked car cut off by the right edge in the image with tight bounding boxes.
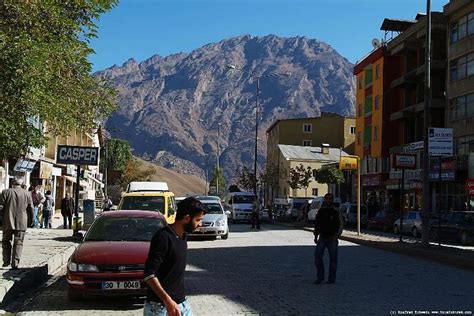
[430,212,474,245]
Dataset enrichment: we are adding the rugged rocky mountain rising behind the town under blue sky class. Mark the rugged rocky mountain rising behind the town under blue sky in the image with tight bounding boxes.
[96,35,355,185]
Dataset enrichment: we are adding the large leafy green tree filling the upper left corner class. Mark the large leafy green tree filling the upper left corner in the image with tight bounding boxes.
[0,0,117,159]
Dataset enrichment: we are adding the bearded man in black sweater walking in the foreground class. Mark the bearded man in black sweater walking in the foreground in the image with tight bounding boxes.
[143,197,205,316]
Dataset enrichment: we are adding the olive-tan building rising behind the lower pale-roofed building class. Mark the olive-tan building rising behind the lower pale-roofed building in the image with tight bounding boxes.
[265,113,355,203]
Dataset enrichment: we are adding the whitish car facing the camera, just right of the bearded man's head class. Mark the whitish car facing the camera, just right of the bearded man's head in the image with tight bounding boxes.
[190,199,229,239]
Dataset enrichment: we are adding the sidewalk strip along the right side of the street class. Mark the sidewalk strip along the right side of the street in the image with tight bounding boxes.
[274,222,474,271]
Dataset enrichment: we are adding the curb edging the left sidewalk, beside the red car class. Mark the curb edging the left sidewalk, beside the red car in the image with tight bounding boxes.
[0,245,77,306]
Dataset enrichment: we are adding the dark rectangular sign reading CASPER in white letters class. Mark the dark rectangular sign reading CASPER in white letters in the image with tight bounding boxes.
[56,145,99,166]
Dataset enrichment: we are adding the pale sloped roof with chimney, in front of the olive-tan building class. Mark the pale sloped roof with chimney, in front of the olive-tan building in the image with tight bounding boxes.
[278,145,349,162]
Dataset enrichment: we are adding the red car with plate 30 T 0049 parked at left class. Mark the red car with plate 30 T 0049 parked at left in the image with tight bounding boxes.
[66,211,166,301]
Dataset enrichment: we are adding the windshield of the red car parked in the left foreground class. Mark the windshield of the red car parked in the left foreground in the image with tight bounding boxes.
[84,216,166,241]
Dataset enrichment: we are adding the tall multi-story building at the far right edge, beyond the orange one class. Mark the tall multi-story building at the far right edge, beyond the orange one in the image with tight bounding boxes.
[441,0,474,210]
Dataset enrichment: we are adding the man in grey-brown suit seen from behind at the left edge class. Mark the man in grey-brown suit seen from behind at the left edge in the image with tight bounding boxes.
[0,179,33,270]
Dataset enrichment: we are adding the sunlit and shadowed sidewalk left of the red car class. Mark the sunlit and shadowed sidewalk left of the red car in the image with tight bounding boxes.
[0,214,78,306]
